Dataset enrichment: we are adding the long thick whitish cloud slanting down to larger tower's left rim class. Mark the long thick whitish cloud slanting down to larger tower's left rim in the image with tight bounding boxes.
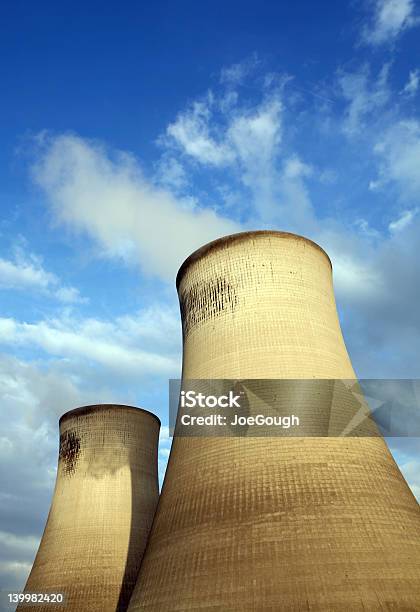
[34,135,240,280]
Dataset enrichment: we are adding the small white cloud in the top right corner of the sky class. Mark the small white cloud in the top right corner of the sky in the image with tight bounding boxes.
[362,0,419,45]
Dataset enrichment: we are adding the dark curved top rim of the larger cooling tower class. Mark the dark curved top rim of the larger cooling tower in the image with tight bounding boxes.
[176,230,332,289]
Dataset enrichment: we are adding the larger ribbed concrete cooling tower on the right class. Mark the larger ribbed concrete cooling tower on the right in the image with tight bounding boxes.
[129,232,420,612]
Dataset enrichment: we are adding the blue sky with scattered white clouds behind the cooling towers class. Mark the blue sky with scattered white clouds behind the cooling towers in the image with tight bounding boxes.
[0,0,420,588]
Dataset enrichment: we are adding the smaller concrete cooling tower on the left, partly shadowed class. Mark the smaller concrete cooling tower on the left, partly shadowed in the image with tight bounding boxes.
[18,404,160,612]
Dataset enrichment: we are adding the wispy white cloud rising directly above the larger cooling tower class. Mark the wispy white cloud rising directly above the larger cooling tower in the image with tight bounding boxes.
[160,79,311,227]
